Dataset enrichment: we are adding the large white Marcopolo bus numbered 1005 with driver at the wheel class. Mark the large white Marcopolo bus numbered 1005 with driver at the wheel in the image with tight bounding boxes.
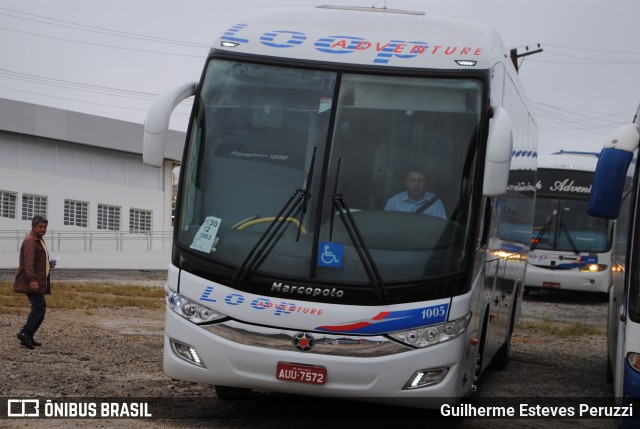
[144,6,537,408]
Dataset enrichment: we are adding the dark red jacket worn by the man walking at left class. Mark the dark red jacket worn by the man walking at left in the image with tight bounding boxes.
[13,231,51,294]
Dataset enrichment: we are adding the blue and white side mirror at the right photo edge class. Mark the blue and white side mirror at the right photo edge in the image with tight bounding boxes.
[587,124,640,219]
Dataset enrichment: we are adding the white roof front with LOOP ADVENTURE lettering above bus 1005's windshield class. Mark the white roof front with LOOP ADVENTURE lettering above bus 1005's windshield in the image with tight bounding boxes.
[218,6,513,70]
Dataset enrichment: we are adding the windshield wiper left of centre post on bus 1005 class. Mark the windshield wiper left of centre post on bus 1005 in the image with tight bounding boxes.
[233,147,316,285]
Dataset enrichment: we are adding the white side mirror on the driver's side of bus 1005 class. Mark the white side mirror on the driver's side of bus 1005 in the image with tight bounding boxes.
[482,106,513,197]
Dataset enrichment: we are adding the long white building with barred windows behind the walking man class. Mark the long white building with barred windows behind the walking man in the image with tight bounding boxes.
[0,99,184,269]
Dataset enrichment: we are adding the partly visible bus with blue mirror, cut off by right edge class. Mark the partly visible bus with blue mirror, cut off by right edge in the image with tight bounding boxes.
[589,108,640,428]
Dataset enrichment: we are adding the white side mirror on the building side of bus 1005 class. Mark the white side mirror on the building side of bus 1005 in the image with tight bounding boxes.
[142,82,196,167]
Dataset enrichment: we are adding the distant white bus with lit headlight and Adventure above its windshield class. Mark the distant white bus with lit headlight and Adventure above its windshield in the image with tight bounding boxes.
[526,151,614,297]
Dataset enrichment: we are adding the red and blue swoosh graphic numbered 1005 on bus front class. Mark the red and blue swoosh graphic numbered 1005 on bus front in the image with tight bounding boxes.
[316,304,449,334]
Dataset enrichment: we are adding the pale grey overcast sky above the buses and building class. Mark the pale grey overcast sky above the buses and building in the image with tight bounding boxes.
[0,0,640,154]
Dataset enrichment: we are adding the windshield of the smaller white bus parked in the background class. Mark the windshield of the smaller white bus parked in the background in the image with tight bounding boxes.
[531,197,612,254]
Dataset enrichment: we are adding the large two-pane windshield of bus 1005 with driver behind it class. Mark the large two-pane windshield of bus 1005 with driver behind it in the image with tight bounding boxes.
[177,58,483,285]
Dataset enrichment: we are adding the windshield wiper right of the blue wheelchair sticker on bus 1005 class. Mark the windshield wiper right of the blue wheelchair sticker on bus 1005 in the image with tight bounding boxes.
[329,158,389,300]
